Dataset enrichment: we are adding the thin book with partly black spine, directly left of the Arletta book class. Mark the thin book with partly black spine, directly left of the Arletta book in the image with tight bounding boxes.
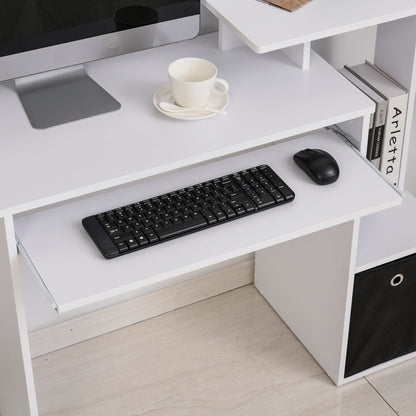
[339,65,388,169]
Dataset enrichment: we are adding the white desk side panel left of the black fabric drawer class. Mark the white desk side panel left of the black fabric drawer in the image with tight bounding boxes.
[254,220,359,385]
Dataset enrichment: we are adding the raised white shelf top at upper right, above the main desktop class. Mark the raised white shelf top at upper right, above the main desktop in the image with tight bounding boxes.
[203,0,416,53]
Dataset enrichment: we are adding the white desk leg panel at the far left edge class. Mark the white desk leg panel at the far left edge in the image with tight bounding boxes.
[0,216,38,416]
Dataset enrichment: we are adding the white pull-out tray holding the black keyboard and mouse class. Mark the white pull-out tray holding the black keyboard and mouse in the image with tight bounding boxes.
[15,130,401,312]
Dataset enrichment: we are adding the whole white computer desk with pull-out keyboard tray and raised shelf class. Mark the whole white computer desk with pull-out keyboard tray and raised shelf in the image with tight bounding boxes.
[0,0,416,416]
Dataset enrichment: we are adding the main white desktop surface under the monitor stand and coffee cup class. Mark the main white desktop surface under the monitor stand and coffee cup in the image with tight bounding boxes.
[0,33,374,213]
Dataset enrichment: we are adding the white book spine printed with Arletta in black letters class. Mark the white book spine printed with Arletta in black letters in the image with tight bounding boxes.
[380,94,407,185]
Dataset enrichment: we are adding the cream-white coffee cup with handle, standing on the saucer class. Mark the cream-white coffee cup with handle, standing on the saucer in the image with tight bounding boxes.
[168,58,228,108]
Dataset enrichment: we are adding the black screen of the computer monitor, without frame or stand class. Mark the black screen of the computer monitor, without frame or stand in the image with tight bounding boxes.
[0,0,200,56]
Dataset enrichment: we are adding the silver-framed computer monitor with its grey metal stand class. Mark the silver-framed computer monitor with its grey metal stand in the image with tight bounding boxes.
[0,0,200,128]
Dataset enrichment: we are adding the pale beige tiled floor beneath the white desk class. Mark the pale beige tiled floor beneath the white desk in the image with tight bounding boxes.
[33,285,416,416]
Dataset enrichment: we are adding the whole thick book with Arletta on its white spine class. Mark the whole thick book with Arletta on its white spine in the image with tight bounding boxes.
[349,61,408,186]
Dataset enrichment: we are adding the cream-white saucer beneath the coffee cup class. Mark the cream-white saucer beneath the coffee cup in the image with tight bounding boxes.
[153,84,228,120]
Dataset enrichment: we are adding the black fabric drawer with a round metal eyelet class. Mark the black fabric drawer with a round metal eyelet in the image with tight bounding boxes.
[345,254,416,377]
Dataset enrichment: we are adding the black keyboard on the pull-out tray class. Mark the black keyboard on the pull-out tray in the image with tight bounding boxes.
[82,165,295,259]
